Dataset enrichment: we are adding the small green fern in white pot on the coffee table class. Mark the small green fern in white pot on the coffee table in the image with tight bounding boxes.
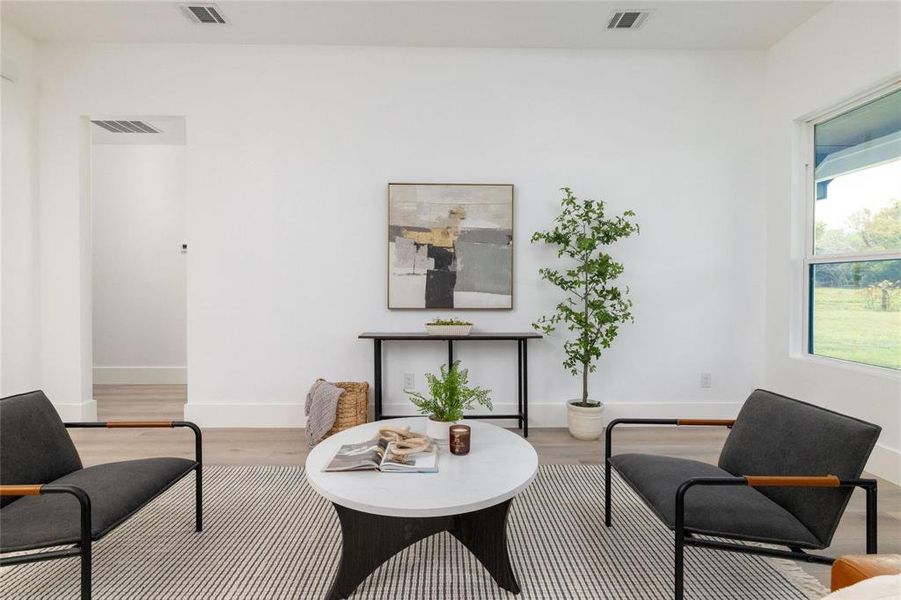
[407,360,493,440]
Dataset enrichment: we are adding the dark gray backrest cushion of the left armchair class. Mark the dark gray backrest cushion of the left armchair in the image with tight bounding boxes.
[0,391,81,506]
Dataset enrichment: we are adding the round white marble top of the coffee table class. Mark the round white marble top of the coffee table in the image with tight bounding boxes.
[306,417,538,517]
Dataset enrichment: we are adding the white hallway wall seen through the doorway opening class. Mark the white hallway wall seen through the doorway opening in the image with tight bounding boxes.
[91,144,187,383]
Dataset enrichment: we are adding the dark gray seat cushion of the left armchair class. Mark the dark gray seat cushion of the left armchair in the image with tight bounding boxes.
[0,458,196,552]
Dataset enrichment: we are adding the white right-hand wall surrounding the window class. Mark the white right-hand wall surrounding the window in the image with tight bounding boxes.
[765,2,901,483]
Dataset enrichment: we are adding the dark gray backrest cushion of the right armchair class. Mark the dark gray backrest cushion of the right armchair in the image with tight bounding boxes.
[719,390,881,547]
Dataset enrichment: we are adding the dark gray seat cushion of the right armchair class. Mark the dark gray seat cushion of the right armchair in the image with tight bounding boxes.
[610,454,823,548]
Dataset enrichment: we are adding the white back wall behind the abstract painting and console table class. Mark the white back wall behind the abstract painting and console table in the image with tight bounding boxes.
[40,45,764,426]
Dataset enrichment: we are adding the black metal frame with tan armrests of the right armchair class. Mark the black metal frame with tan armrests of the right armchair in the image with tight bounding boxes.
[604,419,877,600]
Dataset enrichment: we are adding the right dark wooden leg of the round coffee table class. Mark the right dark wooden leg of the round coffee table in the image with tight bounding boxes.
[450,500,520,594]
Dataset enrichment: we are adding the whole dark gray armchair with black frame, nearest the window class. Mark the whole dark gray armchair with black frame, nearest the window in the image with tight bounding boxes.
[604,390,881,600]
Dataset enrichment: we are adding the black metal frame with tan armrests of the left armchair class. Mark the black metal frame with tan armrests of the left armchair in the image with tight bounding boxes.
[0,421,203,600]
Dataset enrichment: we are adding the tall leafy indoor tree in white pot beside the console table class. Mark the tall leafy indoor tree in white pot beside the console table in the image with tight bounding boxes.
[532,188,638,440]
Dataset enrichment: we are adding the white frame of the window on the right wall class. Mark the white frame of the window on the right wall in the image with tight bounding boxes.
[800,80,901,374]
